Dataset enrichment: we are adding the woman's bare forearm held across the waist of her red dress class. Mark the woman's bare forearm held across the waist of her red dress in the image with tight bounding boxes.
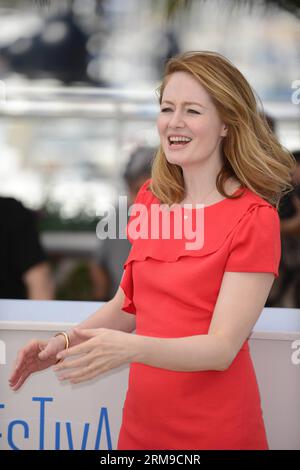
[130,335,231,372]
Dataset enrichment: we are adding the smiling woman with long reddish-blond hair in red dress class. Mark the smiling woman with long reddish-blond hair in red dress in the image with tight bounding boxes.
[10,52,293,450]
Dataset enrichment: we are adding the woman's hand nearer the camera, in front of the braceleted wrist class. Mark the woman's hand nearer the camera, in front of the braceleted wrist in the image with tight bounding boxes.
[53,328,136,383]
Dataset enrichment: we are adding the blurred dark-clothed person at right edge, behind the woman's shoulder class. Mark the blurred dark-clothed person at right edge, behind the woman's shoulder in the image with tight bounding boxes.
[266,150,300,308]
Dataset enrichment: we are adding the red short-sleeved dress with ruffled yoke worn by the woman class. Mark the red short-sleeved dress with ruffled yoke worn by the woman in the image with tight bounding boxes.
[117,180,280,450]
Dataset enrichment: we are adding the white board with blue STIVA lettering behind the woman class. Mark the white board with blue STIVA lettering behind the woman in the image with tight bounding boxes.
[0,300,300,450]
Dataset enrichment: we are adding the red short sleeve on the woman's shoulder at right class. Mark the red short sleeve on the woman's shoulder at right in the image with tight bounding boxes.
[225,205,281,277]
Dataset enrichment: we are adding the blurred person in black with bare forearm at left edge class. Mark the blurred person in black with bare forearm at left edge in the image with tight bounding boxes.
[0,197,54,299]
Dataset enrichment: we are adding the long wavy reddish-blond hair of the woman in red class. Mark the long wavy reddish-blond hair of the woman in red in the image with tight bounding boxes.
[150,51,296,209]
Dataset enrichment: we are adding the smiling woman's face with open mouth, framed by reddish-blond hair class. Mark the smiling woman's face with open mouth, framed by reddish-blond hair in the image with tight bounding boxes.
[157,72,227,167]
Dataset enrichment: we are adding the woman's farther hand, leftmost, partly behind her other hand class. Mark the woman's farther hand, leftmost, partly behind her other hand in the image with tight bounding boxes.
[9,335,65,391]
